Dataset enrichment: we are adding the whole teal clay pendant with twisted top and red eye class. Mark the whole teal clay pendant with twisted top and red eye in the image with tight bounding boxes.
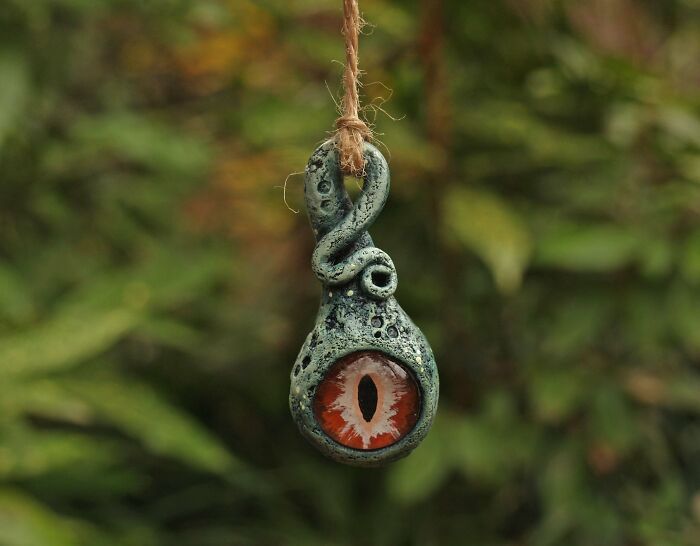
[289,141,439,466]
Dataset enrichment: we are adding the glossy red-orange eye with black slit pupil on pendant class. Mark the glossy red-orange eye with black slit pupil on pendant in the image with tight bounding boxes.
[314,352,420,450]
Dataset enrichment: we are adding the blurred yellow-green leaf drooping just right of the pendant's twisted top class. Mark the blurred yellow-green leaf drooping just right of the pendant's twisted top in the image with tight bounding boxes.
[444,188,532,294]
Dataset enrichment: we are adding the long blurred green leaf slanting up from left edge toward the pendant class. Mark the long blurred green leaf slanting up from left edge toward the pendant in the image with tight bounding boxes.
[0,252,228,376]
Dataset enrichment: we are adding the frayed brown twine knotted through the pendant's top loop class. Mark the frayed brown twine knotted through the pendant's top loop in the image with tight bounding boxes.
[335,0,372,177]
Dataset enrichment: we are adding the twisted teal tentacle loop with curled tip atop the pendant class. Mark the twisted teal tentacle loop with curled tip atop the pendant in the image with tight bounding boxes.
[304,142,398,300]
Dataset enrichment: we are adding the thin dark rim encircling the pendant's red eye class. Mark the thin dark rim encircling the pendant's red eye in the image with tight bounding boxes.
[309,347,424,450]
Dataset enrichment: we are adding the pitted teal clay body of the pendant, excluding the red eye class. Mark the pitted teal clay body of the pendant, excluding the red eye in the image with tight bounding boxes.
[289,141,439,466]
